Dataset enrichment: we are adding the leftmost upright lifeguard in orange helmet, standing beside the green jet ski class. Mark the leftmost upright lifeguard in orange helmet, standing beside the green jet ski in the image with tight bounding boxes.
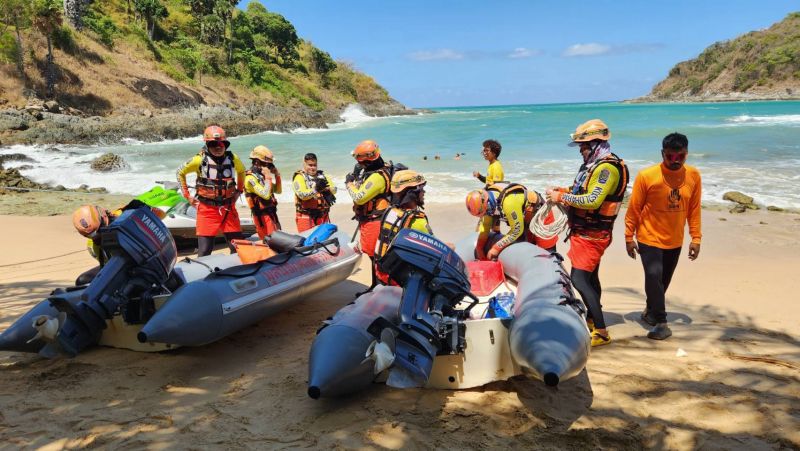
[177,125,245,257]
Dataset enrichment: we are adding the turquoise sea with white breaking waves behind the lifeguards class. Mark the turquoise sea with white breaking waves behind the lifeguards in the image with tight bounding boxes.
[0,102,800,208]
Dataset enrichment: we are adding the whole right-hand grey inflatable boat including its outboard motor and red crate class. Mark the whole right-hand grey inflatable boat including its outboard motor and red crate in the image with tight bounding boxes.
[308,230,590,399]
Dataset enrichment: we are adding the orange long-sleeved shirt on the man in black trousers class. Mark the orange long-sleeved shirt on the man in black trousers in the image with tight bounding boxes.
[625,163,702,249]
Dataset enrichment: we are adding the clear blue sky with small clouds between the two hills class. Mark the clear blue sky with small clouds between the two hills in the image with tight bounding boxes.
[247,0,800,107]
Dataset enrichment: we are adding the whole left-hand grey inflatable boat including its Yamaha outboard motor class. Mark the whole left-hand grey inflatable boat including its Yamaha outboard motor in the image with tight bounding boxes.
[0,208,361,357]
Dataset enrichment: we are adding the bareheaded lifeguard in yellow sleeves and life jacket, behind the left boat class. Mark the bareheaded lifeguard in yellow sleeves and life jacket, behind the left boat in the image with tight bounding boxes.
[292,153,336,232]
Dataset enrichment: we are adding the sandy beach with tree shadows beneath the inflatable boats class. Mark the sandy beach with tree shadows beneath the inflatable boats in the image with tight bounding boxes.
[0,205,800,450]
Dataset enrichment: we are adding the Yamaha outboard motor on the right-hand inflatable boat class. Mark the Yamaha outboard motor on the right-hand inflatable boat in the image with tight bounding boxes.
[374,229,478,388]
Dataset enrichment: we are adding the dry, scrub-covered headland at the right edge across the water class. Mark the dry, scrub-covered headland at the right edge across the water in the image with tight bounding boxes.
[629,12,800,103]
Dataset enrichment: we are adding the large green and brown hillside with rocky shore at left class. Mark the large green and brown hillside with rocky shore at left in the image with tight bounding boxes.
[0,0,415,145]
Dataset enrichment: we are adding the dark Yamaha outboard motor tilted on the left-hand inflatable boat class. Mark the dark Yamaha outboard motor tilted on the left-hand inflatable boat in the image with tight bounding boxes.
[50,208,177,356]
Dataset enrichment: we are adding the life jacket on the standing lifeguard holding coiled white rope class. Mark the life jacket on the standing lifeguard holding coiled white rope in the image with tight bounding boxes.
[569,153,630,231]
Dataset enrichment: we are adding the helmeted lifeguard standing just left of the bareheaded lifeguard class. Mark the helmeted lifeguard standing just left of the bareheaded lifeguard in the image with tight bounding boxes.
[244,146,283,240]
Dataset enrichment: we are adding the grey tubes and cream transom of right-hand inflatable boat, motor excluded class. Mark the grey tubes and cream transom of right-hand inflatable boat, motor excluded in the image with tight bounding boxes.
[308,234,590,398]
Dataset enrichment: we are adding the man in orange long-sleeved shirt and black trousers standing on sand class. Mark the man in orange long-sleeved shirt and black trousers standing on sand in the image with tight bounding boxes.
[625,133,702,340]
